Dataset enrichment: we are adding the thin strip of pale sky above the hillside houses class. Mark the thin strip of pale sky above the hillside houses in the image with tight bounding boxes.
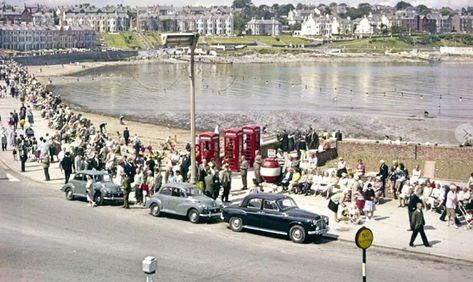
[5,0,473,8]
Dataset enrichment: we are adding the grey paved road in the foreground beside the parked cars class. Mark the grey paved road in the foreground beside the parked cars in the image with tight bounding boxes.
[0,167,473,282]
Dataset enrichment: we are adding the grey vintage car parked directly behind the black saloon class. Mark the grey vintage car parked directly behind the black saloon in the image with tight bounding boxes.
[145,183,223,223]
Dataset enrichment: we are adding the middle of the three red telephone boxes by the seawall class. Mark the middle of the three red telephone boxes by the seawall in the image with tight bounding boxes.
[223,128,243,171]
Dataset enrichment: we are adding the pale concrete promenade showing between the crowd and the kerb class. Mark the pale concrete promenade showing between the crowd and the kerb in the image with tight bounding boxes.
[0,97,473,261]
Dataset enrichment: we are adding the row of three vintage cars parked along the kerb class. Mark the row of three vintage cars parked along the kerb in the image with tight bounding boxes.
[61,170,329,243]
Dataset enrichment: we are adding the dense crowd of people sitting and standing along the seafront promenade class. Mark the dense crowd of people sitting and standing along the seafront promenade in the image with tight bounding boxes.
[0,61,473,249]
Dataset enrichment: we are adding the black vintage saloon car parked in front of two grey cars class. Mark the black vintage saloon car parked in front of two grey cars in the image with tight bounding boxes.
[223,193,329,243]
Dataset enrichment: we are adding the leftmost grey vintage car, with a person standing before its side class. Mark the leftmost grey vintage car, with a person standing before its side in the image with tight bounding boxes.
[61,170,123,205]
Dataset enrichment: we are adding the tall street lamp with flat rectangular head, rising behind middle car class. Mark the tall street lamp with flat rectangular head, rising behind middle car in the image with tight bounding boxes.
[163,33,199,184]
